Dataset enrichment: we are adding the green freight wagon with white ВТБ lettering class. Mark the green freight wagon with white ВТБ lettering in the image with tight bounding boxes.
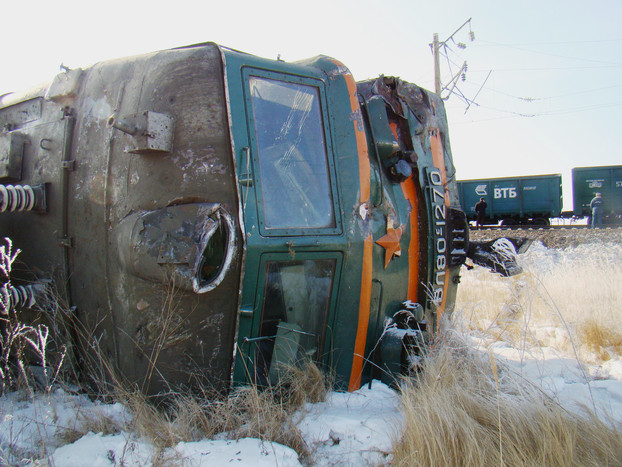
[458,174,562,226]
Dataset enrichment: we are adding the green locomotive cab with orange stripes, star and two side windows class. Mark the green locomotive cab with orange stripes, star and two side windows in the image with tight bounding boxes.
[224,50,468,390]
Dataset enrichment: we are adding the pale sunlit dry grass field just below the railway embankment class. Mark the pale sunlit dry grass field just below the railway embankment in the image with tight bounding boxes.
[455,244,622,363]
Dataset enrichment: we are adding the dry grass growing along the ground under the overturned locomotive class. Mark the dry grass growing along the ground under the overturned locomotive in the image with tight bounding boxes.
[31,272,332,464]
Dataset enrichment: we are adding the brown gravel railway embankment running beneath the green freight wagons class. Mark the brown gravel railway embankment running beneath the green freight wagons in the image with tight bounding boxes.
[470,227,622,249]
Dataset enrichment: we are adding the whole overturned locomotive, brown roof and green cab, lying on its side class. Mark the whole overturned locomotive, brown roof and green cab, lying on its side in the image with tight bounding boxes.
[0,43,515,393]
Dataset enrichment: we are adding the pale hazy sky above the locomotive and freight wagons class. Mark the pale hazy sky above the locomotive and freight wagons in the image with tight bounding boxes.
[0,0,622,209]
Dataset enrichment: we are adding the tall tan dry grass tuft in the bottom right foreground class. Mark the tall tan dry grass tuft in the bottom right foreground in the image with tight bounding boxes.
[393,333,622,467]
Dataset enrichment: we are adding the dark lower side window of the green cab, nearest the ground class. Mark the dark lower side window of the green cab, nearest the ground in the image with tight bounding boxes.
[256,259,336,384]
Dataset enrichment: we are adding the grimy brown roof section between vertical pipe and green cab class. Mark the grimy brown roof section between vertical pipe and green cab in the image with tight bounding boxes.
[64,45,241,392]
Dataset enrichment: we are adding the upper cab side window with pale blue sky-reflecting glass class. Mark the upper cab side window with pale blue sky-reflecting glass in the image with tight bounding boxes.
[249,76,336,234]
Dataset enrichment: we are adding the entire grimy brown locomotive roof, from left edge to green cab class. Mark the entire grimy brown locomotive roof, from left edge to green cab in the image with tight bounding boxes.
[0,44,242,393]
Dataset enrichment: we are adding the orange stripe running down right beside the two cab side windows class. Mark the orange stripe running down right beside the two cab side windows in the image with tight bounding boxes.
[332,60,374,391]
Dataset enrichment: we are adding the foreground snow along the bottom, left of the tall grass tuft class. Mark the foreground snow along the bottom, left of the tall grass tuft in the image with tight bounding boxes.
[0,381,401,467]
